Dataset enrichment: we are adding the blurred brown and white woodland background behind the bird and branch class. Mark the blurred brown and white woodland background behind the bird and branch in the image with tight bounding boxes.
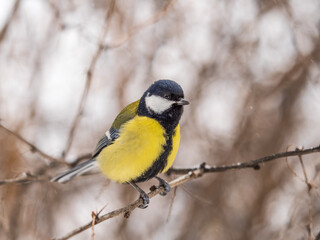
[0,0,320,240]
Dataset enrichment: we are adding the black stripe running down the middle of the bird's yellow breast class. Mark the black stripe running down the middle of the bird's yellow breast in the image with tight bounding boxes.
[132,131,175,183]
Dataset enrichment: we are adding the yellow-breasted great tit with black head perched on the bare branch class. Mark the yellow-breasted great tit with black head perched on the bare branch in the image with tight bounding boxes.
[51,80,189,208]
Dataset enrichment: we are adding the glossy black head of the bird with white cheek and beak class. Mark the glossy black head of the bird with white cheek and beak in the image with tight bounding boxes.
[138,80,189,131]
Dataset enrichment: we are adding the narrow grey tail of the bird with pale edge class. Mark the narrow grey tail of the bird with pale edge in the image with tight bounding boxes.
[51,158,97,183]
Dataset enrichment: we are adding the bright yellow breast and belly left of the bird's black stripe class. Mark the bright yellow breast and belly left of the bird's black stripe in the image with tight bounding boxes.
[97,116,166,182]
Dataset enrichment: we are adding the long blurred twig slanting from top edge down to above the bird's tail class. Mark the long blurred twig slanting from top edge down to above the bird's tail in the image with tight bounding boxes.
[62,0,115,157]
